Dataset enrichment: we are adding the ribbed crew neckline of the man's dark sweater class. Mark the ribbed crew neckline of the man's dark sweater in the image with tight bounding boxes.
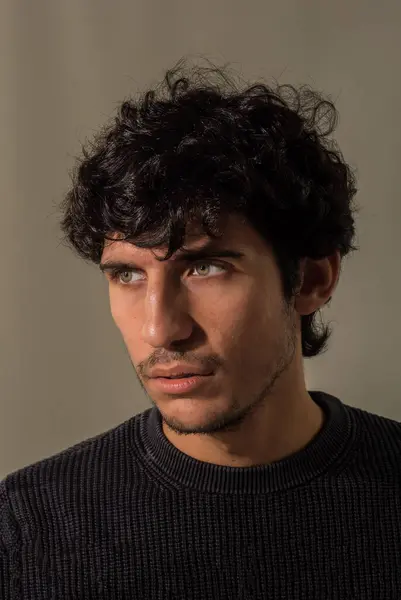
[134,391,356,494]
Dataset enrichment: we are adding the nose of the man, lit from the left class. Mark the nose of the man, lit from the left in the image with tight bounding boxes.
[141,281,193,348]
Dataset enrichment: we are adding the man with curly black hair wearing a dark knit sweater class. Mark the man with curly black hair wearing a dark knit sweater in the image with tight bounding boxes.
[0,63,401,600]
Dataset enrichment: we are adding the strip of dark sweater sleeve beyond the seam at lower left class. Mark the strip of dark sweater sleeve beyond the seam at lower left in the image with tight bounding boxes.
[0,479,21,600]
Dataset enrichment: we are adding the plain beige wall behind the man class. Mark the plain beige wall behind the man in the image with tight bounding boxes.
[0,0,401,477]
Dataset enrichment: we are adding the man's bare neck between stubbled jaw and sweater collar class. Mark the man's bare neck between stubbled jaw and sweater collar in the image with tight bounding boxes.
[163,386,324,467]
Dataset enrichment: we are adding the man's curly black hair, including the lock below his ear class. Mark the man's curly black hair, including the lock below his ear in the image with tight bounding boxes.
[61,61,357,357]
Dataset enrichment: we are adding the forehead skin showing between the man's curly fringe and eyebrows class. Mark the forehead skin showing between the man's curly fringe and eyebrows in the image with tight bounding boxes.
[102,215,269,259]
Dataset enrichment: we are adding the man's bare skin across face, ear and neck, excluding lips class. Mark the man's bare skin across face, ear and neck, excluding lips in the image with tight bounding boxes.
[101,216,340,467]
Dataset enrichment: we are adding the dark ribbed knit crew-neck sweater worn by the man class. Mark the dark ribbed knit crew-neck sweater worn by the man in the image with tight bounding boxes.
[0,392,401,600]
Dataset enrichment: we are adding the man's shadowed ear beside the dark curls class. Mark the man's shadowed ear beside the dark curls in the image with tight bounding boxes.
[295,252,341,315]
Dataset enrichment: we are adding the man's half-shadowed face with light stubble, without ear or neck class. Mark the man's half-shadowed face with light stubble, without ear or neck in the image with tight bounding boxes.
[102,217,297,433]
